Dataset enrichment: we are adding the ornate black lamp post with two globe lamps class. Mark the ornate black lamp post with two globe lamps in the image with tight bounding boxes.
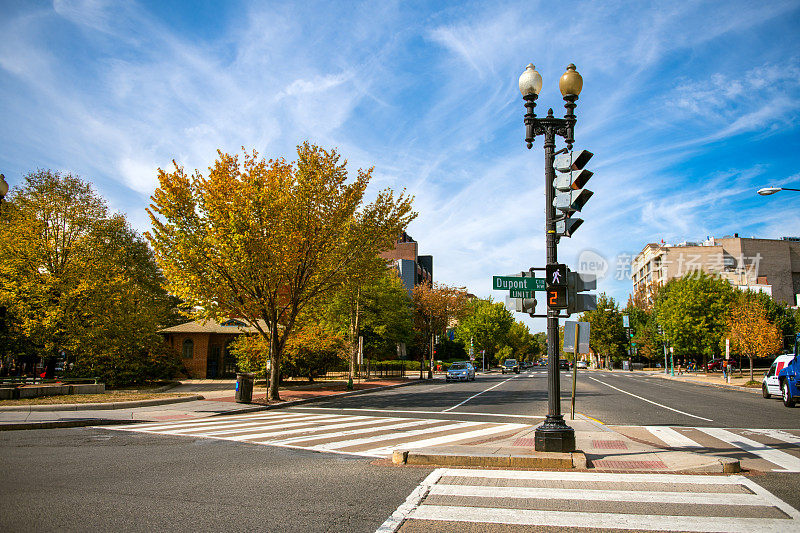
[519,64,583,452]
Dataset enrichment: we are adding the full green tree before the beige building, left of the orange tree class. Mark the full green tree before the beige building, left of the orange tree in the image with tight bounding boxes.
[654,272,735,371]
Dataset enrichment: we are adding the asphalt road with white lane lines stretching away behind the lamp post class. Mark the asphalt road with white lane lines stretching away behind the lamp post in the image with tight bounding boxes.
[309,369,800,429]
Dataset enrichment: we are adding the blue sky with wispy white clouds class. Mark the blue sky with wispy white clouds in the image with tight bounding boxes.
[0,0,800,330]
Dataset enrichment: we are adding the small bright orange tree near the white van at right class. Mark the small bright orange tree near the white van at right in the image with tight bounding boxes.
[725,293,783,381]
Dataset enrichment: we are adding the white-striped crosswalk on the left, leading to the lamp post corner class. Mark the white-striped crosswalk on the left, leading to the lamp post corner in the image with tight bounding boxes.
[106,411,530,457]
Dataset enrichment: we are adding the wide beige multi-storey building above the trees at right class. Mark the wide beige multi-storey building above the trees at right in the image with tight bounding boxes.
[631,234,800,306]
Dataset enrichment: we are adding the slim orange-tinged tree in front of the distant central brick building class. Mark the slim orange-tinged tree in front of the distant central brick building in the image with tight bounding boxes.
[411,283,468,373]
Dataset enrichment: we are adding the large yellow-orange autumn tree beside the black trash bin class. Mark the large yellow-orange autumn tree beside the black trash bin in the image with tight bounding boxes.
[148,142,416,400]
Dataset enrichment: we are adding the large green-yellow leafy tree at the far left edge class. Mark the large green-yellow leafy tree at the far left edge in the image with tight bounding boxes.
[0,170,180,386]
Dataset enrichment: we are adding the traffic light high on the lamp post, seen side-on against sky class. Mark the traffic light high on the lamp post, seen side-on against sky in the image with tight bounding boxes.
[553,150,594,237]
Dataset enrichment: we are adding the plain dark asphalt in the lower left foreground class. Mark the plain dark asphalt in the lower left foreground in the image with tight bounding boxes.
[0,428,431,532]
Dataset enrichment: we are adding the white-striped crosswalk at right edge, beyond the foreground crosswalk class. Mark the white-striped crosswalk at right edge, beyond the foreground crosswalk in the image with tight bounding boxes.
[612,426,800,472]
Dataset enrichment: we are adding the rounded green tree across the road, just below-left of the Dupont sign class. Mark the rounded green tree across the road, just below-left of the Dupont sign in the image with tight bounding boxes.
[456,298,514,363]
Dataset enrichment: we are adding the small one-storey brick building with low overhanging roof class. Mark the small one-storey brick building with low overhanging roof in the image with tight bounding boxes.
[159,319,266,378]
